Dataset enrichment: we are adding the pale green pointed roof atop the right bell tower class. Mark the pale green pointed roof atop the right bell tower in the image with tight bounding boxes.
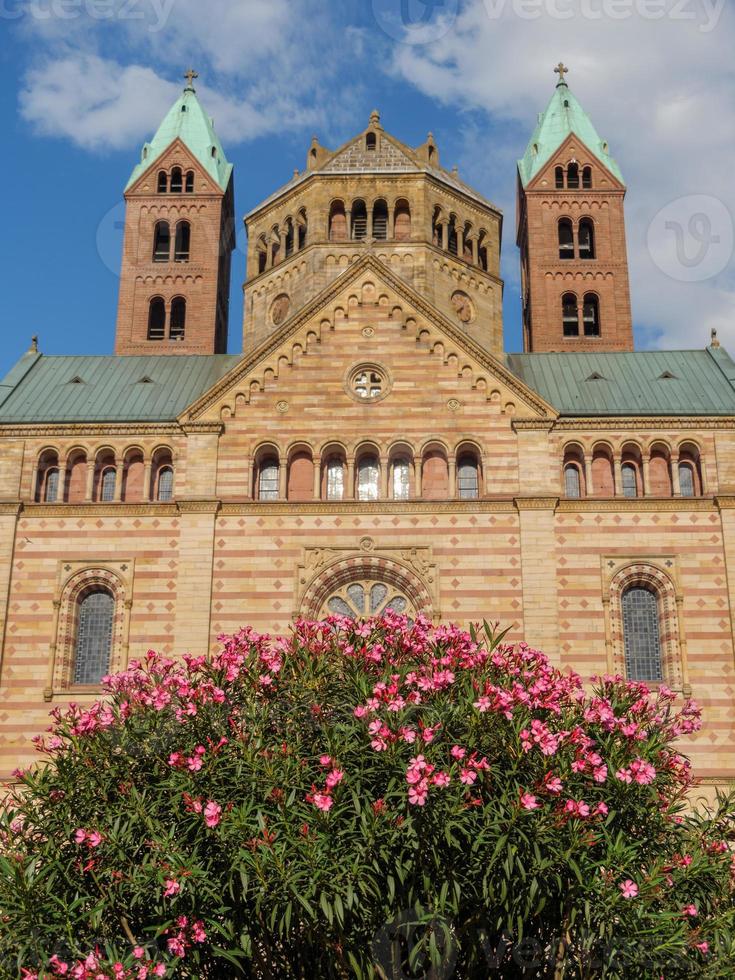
[518,82,625,187]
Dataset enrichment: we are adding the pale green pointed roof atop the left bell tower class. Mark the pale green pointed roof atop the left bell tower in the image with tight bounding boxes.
[125,88,232,190]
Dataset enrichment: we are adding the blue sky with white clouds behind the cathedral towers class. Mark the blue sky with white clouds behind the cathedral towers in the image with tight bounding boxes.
[0,0,735,375]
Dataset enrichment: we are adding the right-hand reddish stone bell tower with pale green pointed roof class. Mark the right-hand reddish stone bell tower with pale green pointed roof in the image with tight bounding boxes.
[517,63,633,352]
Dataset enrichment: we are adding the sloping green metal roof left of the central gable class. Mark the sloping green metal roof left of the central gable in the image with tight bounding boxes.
[0,352,240,424]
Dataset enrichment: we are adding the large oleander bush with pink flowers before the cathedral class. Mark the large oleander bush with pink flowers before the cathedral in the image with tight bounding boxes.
[0,612,735,980]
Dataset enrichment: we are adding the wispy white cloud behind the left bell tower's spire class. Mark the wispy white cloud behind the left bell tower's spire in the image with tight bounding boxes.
[20,0,359,150]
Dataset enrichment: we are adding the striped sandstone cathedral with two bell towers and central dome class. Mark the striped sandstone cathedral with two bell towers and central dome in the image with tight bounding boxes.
[0,65,735,795]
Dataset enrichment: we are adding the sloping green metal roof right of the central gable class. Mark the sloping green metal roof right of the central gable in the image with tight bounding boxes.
[506,347,735,415]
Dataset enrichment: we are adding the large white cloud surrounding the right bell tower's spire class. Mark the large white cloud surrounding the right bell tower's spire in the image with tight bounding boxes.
[393,0,735,349]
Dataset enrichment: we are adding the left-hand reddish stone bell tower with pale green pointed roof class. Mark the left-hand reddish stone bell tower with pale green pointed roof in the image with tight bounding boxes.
[115,70,235,354]
